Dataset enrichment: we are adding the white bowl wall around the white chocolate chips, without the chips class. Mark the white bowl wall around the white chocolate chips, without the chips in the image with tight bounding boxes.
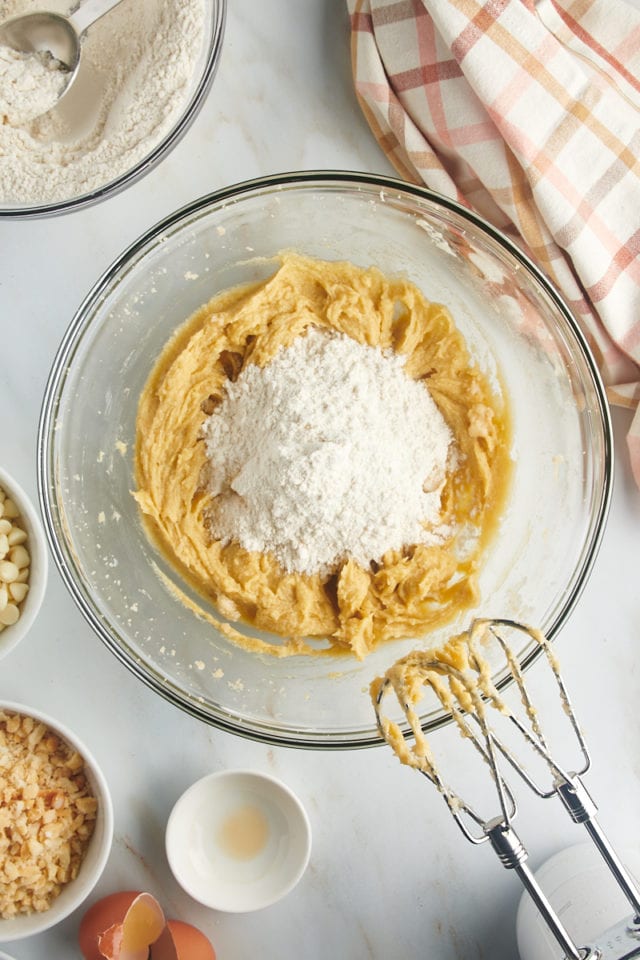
[0,467,49,659]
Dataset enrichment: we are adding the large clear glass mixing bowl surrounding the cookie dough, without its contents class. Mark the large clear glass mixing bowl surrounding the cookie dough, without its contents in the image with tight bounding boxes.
[39,172,612,747]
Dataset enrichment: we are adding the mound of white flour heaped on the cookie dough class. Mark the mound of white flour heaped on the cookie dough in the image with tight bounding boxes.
[204,329,453,574]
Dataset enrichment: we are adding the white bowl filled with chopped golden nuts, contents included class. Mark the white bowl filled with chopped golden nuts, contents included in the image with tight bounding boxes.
[0,701,113,943]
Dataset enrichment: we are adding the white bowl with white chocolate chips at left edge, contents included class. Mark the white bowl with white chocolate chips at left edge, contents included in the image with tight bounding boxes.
[0,467,48,658]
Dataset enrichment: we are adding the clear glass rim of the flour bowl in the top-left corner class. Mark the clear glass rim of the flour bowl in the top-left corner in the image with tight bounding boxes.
[0,0,227,219]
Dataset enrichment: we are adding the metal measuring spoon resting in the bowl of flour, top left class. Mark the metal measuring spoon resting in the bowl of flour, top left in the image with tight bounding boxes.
[0,0,127,97]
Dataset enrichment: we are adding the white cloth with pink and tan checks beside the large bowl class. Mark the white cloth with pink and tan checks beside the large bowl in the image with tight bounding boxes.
[347,0,640,486]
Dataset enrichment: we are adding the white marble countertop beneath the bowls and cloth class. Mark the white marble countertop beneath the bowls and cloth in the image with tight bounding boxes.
[0,0,640,960]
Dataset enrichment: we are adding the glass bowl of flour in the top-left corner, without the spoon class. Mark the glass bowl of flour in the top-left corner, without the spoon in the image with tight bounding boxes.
[0,0,226,217]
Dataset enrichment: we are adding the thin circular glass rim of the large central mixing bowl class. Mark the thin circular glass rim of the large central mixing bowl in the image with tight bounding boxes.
[37,170,614,750]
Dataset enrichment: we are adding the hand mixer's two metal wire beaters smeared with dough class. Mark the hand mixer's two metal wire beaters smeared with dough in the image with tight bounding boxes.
[372,619,640,960]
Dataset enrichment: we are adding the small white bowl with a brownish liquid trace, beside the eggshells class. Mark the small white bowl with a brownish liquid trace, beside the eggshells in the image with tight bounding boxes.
[166,770,311,913]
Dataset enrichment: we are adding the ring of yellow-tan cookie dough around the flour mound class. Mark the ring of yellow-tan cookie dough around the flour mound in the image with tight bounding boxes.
[135,253,510,659]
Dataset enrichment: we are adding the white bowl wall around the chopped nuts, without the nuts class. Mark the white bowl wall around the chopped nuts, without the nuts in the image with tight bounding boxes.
[0,700,113,940]
